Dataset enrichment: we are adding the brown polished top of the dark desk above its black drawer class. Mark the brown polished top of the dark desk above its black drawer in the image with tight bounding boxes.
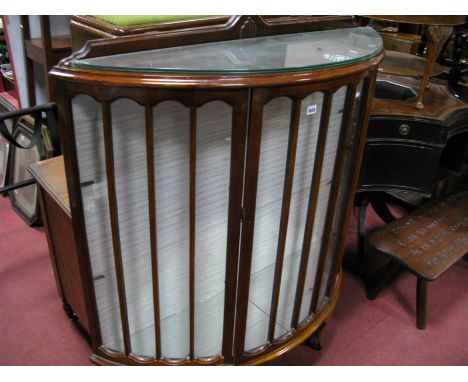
[371,75,468,121]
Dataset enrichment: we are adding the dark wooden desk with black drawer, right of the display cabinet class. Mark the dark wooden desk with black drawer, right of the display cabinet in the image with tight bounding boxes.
[359,75,468,197]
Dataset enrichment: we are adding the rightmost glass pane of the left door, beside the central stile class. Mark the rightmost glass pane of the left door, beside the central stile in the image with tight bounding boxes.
[195,101,232,357]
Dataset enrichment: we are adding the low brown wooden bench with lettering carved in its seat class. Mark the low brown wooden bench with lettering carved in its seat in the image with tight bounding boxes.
[368,191,468,329]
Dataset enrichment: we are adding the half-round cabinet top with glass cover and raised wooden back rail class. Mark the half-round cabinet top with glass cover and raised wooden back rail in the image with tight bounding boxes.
[51,18,383,89]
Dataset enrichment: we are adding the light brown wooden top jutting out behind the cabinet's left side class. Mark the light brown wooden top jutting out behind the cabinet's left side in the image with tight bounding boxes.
[29,156,71,217]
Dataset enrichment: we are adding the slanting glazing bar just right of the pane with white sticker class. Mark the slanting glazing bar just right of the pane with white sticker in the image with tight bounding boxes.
[291,93,332,328]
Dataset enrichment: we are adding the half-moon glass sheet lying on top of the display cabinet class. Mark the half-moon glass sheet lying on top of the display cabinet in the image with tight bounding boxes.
[70,27,383,74]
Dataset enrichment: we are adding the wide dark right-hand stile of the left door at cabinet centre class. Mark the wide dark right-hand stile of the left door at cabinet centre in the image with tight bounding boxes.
[222,103,247,363]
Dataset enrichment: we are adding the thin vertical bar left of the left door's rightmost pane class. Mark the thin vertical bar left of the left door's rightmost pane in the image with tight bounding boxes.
[189,106,197,360]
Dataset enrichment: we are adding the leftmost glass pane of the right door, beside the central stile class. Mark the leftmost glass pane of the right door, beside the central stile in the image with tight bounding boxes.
[245,97,292,350]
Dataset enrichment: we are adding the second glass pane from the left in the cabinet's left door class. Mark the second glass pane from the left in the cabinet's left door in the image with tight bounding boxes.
[111,99,155,357]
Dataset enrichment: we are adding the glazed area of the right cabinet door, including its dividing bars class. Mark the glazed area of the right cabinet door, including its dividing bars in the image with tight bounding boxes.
[241,86,348,353]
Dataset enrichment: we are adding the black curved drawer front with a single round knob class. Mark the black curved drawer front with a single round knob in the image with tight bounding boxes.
[367,117,448,145]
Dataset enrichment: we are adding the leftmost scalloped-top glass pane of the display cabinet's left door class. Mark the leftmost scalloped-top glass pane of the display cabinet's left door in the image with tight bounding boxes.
[72,95,124,351]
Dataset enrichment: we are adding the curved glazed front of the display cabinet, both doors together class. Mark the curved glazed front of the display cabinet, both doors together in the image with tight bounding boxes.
[58,72,371,365]
